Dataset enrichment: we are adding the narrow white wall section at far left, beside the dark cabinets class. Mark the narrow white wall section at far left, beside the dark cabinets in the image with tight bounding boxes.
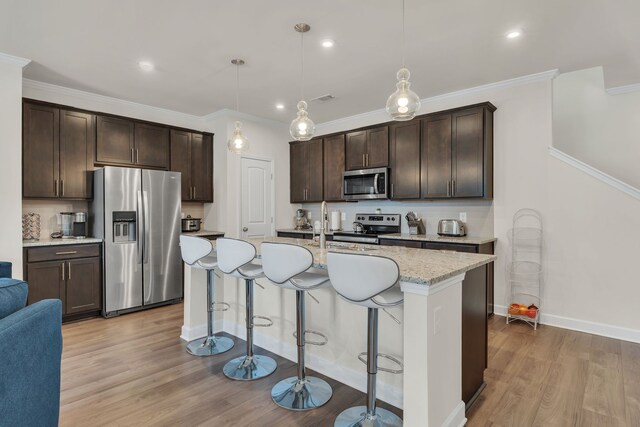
[0,53,28,278]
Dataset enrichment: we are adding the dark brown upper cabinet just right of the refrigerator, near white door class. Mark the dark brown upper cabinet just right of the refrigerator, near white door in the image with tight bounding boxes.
[170,129,213,202]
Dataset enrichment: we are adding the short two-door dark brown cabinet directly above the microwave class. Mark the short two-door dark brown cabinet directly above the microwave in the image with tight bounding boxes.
[345,126,389,170]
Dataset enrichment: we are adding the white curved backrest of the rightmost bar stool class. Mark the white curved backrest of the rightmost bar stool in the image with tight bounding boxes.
[327,252,400,302]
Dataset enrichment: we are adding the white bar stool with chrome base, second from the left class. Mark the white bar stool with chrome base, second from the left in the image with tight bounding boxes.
[216,237,278,381]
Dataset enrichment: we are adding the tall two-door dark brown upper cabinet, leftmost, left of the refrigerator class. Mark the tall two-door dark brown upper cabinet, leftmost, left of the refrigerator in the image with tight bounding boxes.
[22,102,95,199]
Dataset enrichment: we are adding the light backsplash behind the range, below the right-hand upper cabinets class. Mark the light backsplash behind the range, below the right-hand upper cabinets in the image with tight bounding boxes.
[302,200,494,237]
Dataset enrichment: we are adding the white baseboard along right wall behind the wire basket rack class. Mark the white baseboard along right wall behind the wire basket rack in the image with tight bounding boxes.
[494,305,640,343]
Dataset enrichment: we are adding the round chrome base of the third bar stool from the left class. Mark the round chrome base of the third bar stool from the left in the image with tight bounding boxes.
[271,377,333,411]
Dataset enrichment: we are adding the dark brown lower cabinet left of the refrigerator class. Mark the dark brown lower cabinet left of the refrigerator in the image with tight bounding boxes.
[24,244,102,321]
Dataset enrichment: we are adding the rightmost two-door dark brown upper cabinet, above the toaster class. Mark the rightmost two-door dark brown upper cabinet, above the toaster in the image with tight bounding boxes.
[421,103,495,199]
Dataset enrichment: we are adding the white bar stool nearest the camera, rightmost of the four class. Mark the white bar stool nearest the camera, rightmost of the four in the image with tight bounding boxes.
[327,252,404,427]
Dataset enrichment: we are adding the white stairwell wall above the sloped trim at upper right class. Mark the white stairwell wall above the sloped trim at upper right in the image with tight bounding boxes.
[553,67,640,188]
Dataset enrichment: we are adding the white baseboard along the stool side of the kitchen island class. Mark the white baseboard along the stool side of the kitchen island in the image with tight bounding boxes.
[219,319,400,410]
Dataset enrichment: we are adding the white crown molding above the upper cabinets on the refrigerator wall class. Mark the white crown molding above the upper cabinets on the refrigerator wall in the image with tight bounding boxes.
[22,79,203,126]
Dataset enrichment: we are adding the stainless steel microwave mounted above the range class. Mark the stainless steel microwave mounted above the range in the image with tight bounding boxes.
[342,168,389,200]
